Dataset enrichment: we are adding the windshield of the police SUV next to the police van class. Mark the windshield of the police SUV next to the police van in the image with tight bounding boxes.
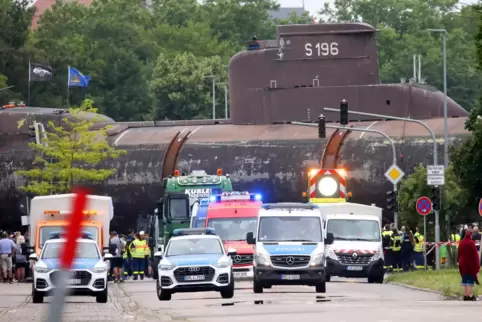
[166,238,223,257]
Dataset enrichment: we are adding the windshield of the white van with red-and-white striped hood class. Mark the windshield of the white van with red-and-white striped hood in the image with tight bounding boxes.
[326,219,381,242]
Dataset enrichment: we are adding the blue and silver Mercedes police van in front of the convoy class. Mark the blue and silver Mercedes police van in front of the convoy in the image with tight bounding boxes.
[246,203,333,293]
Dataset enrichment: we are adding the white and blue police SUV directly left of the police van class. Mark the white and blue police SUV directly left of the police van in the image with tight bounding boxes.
[156,228,236,301]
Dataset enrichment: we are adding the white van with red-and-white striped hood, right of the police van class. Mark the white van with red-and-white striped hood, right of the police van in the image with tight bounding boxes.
[319,202,384,283]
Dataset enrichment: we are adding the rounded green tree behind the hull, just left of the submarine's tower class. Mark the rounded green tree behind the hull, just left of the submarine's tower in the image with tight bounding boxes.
[151,53,226,120]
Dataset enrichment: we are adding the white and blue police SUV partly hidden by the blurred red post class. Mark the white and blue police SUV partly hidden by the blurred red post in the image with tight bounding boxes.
[29,232,112,303]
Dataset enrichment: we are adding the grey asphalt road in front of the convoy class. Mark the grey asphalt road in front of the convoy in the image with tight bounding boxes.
[0,279,481,322]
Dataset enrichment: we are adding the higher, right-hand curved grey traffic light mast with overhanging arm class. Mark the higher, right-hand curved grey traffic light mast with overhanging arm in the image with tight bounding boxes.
[324,107,440,270]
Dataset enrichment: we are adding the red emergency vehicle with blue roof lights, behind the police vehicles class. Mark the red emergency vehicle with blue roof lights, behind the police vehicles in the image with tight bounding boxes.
[206,191,262,279]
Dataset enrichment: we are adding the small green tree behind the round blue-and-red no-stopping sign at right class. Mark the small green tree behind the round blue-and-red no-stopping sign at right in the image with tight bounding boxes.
[398,164,466,238]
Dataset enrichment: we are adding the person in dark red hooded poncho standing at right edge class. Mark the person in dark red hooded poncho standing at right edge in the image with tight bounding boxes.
[459,231,480,301]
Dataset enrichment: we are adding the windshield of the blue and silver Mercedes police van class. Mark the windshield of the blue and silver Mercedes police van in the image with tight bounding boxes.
[258,216,322,242]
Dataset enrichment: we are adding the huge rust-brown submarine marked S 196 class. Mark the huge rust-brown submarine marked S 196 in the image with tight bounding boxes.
[0,23,469,230]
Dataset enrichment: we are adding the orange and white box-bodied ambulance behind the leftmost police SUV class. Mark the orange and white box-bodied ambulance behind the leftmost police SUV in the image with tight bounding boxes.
[28,194,114,256]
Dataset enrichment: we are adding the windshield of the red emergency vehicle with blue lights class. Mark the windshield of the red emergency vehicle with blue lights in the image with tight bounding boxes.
[208,218,258,241]
